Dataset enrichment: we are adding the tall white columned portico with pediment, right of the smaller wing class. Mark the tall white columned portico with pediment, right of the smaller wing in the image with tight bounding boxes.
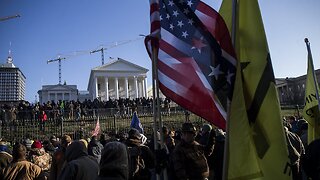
[88,58,148,101]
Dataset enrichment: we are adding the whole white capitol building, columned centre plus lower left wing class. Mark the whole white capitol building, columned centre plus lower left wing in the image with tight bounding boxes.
[38,58,149,103]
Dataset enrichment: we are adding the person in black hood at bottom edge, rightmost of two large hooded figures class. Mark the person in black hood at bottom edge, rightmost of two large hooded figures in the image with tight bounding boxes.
[97,141,129,180]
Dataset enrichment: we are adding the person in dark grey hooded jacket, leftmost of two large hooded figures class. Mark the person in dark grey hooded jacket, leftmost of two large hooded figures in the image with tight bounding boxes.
[58,141,99,180]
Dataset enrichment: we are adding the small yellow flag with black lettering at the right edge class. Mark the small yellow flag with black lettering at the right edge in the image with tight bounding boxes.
[303,39,320,143]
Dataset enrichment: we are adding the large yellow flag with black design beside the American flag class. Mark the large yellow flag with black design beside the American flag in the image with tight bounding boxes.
[220,0,291,180]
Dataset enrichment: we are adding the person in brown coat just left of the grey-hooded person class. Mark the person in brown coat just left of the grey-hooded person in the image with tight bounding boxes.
[49,135,72,180]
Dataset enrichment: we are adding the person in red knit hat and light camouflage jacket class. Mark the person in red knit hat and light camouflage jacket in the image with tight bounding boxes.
[28,140,52,173]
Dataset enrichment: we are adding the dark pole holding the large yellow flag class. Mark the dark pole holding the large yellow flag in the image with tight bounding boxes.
[222,0,240,180]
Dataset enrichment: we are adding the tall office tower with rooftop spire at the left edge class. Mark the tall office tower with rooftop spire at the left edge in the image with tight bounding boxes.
[0,54,26,101]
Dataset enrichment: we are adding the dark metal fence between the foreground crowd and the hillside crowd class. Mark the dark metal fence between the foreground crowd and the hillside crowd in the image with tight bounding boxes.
[0,108,203,141]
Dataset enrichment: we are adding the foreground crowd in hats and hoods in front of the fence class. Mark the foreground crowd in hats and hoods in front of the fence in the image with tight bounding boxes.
[0,116,320,180]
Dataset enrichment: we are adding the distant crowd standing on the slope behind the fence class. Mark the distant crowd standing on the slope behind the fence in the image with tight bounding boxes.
[0,97,171,125]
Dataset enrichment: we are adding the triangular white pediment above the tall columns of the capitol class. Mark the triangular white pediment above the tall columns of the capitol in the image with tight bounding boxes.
[92,58,149,73]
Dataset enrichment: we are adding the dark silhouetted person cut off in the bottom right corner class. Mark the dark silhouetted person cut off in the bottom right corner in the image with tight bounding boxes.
[301,139,320,180]
